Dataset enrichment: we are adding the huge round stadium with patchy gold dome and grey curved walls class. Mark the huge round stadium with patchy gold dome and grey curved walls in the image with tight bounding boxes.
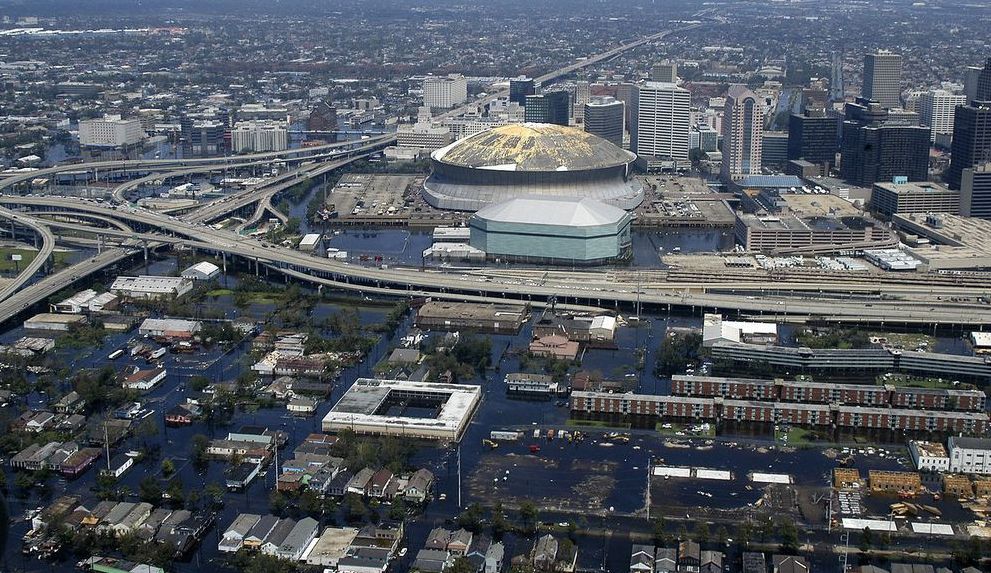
[424,123,643,211]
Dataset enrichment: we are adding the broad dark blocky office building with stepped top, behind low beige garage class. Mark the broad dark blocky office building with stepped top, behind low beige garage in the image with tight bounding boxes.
[840,98,929,187]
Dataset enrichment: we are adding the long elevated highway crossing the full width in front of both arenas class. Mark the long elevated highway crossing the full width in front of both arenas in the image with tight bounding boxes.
[0,197,991,325]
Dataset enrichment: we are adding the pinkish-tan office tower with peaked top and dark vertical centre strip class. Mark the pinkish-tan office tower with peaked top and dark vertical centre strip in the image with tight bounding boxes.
[722,85,764,181]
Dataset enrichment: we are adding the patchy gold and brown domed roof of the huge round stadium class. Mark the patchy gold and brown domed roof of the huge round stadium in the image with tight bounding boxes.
[432,123,636,171]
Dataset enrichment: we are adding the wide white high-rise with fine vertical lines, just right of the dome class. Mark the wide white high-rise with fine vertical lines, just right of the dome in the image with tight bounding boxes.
[630,82,692,161]
